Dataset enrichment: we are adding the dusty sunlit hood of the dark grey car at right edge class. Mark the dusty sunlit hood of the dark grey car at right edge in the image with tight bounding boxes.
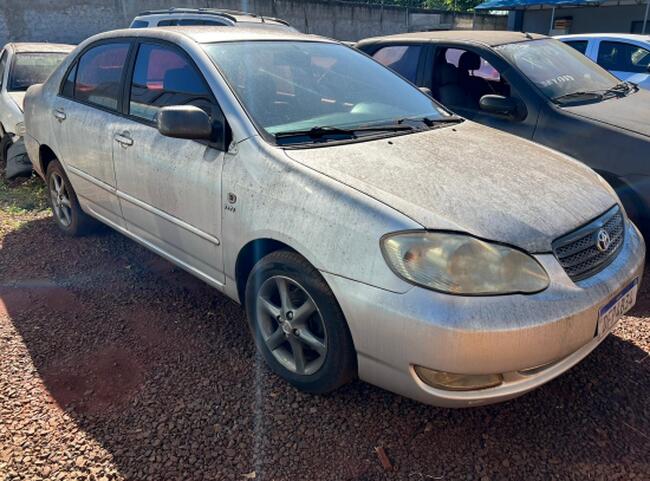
[562,90,650,137]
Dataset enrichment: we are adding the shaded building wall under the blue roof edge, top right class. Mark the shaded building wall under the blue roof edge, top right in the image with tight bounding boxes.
[522,5,646,34]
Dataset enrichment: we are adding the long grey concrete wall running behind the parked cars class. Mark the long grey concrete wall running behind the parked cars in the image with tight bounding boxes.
[0,0,506,46]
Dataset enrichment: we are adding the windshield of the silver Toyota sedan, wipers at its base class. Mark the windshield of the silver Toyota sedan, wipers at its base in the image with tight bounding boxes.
[204,41,450,142]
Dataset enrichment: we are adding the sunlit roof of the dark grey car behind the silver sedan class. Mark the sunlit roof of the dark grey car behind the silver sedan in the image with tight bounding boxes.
[357,30,548,47]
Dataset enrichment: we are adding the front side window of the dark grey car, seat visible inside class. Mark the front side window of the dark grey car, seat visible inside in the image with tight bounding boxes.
[432,47,511,111]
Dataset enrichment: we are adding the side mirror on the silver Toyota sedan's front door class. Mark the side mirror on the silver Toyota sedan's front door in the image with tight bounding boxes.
[156,105,212,140]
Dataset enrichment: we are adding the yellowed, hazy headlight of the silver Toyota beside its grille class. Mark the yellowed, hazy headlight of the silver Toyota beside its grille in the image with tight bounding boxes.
[381,231,549,295]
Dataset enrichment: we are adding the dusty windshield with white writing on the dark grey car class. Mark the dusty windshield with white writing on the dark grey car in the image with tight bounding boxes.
[496,38,620,99]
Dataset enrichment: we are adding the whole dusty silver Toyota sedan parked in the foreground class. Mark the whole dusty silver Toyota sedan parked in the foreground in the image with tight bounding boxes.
[25,27,645,406]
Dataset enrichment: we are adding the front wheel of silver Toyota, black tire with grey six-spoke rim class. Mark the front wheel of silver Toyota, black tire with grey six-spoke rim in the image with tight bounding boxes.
[245,250,357,394]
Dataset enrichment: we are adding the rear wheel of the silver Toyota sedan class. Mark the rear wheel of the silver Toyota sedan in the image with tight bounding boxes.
[45,160,97,237]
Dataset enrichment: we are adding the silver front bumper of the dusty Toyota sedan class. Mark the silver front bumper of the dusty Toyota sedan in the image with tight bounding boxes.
[323,223,645,407]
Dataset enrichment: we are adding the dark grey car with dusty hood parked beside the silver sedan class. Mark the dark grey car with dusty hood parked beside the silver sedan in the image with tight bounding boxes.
[356,31,650,232]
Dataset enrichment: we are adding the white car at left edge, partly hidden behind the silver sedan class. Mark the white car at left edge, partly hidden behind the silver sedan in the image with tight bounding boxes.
[0,43,74,177]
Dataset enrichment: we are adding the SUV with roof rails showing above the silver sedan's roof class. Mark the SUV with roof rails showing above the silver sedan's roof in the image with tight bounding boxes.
[130,8,296,31]
